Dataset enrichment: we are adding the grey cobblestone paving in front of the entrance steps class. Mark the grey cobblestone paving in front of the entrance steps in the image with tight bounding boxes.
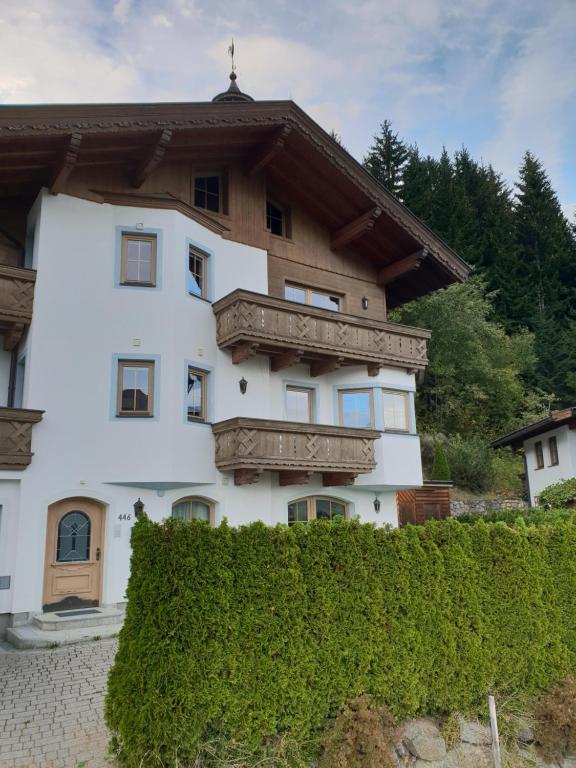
[0,640,116,768]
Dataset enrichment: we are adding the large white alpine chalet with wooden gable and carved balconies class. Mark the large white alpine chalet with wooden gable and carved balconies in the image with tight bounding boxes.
[0,73,468,628]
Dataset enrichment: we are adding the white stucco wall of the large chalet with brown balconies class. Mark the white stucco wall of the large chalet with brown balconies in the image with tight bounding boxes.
[0,194,421,613]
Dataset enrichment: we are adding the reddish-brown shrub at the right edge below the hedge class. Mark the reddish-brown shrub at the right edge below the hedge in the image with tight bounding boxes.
[534,675,576,762]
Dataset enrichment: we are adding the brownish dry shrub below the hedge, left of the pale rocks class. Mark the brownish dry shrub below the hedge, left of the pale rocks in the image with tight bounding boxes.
[319,696,396,768]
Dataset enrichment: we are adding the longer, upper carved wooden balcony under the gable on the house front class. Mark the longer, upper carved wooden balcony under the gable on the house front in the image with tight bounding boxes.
[213,290,430,376]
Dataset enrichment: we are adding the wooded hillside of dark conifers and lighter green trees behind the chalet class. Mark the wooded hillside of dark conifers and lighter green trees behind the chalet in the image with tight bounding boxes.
[363,120,576,488]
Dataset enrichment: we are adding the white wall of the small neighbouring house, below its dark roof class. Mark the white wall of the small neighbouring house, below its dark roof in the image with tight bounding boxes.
[524,426,576,505]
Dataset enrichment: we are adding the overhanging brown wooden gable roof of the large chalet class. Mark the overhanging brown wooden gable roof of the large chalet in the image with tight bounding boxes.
[0,101,470,307]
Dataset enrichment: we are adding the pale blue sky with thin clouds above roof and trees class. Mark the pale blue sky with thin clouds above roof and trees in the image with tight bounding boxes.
[0,0,576,217]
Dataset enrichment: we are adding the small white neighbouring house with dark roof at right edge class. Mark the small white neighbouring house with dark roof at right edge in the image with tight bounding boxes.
[492,408,576,506]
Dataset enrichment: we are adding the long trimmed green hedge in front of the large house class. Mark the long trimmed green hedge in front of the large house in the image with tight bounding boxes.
[106,518,576,767]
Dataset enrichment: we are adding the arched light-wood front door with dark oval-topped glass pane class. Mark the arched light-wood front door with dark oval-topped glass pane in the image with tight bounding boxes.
[43,498,104,611]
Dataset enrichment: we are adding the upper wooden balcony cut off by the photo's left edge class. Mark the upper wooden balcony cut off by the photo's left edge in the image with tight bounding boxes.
[0,264,36,350]
